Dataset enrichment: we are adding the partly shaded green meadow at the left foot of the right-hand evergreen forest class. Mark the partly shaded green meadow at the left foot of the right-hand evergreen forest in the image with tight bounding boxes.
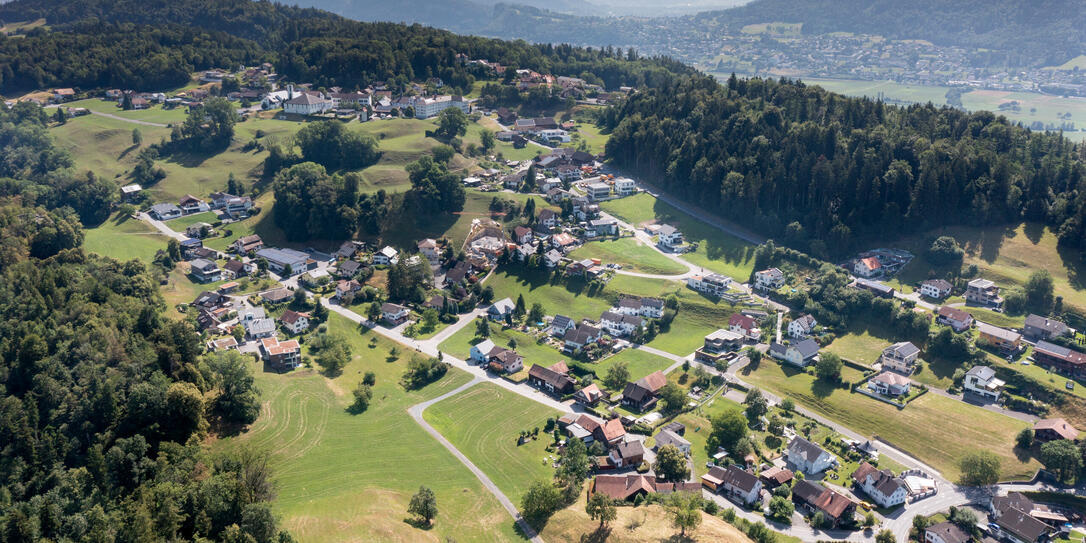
[601,193,755,282]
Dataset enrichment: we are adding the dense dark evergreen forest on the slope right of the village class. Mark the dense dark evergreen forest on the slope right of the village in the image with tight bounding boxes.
[601,76,1086,256]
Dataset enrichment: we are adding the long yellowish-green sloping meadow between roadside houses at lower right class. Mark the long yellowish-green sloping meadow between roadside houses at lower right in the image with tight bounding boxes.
[743,359,1039,480]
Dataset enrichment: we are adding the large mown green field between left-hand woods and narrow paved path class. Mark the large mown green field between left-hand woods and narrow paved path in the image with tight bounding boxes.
[215,314,520,542]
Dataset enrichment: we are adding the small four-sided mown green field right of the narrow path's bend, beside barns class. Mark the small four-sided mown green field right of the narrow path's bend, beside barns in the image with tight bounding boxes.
[422,383,559,504]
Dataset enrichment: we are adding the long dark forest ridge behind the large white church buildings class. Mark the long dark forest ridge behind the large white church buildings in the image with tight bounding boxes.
[0,0,691,91]
